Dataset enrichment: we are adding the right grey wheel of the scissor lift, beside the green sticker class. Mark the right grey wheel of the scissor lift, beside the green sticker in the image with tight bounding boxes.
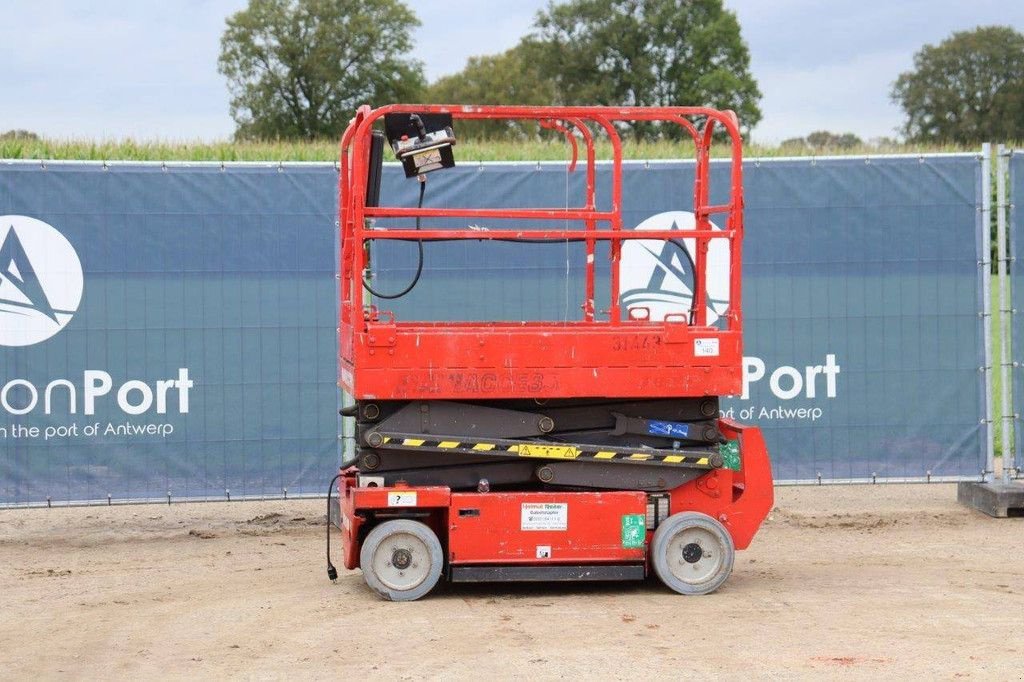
[650,512,736,595]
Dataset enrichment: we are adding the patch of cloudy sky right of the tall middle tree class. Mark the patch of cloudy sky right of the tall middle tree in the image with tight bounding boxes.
[726,0,1024,142]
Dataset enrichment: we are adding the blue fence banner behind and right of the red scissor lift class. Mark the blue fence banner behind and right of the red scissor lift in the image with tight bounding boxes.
[374,154,987,481]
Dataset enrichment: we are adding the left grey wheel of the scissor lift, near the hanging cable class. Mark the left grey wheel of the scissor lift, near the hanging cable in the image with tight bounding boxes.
[359,519,444,601]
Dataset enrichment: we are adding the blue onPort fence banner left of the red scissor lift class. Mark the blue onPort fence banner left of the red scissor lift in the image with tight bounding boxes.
[0,163,339,504]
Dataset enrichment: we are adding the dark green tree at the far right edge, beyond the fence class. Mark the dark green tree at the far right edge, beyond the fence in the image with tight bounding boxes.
[892,26,1024,144]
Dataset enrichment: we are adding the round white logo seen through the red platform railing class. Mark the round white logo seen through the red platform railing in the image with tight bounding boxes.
[618,211,729,325]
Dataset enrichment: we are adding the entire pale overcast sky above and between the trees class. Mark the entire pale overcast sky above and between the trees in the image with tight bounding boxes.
[0,0,1024,142]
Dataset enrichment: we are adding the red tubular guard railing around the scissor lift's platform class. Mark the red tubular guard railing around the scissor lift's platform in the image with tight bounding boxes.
[338,104,743,332]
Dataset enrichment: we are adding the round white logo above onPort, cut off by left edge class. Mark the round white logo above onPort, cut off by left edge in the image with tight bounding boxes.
[0,215,83,346]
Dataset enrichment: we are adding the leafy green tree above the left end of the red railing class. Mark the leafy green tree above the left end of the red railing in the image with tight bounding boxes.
[218,0,424,138]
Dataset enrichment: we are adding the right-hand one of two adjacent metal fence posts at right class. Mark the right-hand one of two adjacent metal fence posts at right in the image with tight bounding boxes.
[995,144,1017,483]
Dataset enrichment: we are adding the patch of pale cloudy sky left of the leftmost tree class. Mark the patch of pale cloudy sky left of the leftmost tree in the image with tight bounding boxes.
[0,0,245,138]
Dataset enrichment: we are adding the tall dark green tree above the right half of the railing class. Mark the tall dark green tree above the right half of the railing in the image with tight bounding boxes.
[524,0,761,137]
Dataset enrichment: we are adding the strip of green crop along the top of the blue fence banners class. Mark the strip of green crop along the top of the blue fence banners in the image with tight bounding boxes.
[0,137,978,162]
